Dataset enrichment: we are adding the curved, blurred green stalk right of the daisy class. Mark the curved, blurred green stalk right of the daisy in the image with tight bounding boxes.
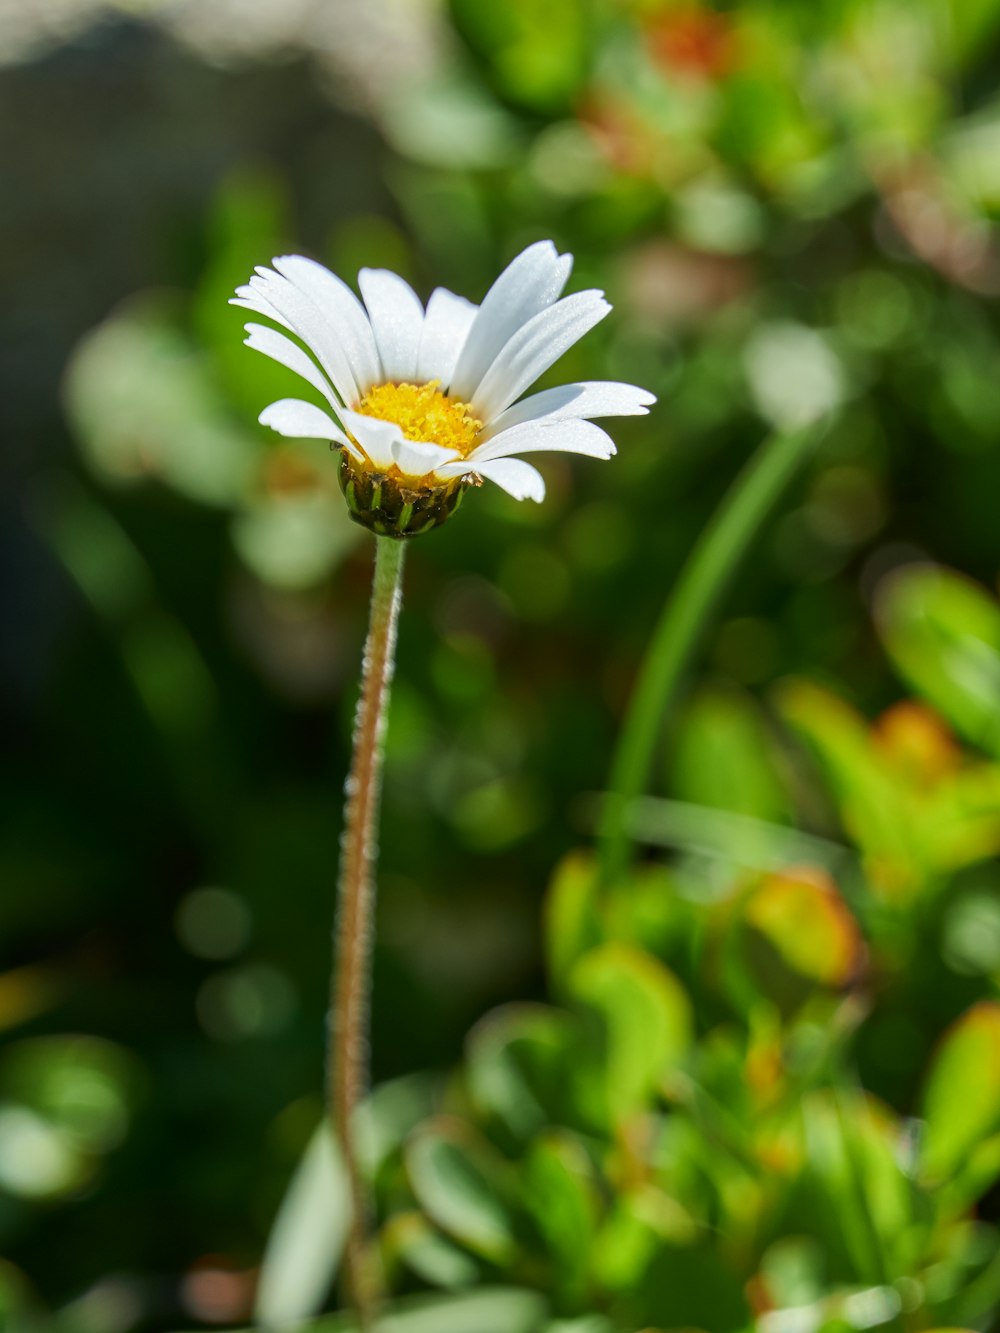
[599,427,821,884]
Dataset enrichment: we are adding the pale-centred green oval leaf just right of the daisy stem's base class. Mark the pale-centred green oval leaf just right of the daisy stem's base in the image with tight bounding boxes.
[407,1121,516,1265]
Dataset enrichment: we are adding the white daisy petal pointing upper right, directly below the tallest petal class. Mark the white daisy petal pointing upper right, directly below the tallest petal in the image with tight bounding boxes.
[469,291,611,424]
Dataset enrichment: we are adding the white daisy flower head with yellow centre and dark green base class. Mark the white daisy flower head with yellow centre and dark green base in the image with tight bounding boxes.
[231,241,656,537]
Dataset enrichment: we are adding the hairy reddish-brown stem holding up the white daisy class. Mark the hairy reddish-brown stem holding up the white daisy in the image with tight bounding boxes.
[328,537,405,1330]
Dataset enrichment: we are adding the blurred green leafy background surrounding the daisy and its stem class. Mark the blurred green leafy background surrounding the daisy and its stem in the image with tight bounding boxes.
[0,0,1000,1333]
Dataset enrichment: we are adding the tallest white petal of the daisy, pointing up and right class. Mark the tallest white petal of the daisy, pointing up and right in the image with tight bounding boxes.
[452,241,573,403]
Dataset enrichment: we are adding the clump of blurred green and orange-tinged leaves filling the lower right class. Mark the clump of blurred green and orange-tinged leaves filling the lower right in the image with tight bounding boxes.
[329,568,1000,1329]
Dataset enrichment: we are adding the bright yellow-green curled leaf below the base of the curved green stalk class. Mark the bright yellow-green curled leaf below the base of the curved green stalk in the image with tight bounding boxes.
[569,942,692,1122]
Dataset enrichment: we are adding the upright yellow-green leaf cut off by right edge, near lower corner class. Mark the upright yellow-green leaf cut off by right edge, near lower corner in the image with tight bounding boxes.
[920,1000,1000,1180]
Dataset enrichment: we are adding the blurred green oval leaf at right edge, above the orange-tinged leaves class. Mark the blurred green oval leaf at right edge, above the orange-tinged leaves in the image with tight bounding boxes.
[876,565,1000,754]
